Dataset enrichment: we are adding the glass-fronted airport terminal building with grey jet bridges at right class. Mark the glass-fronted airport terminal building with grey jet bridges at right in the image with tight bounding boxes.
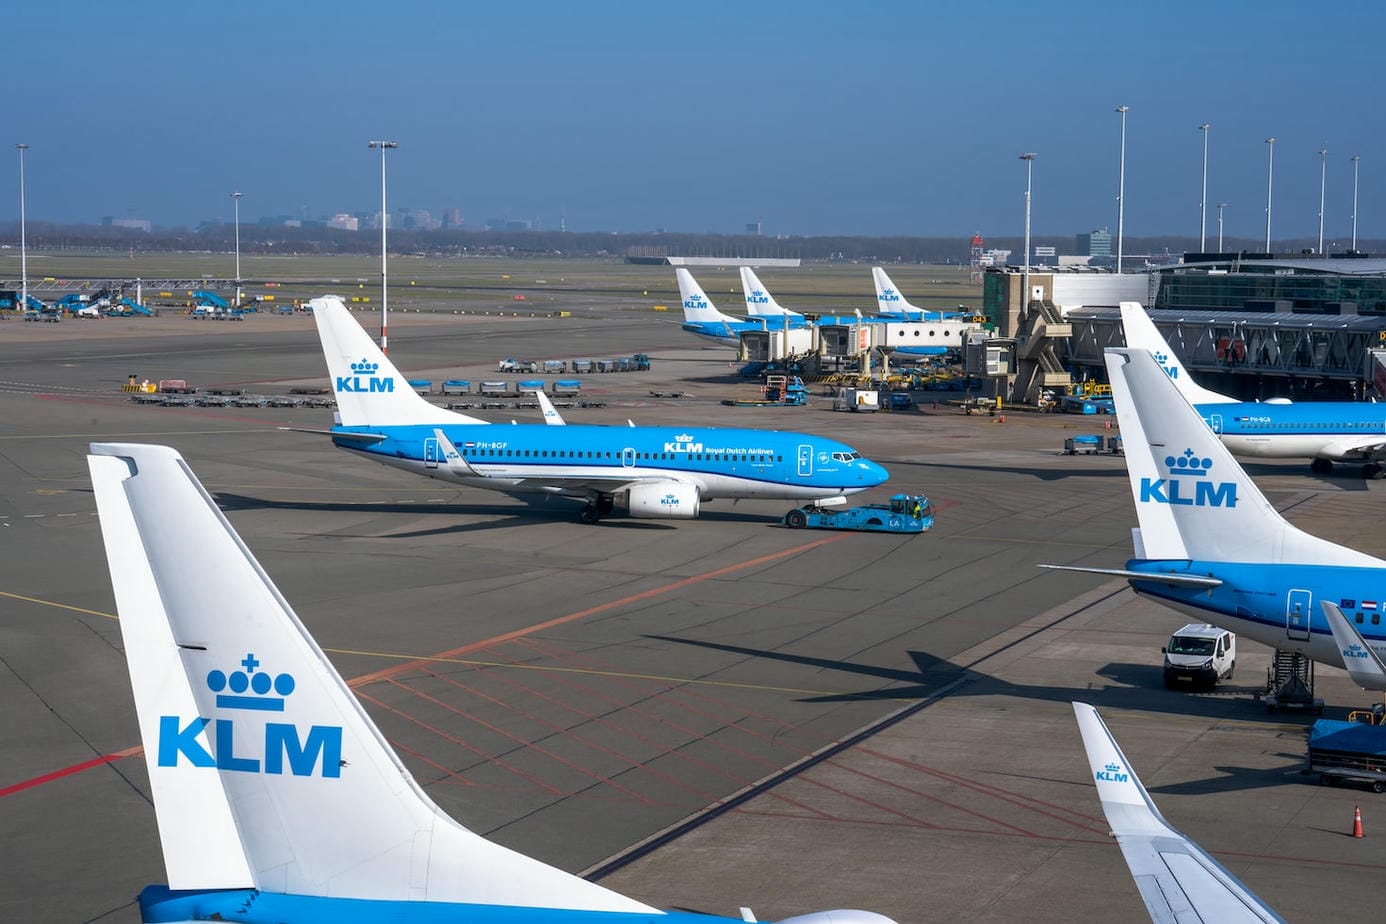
[983,254,1386,403]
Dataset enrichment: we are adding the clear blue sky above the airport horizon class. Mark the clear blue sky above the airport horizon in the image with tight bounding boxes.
[10,0,1386,240]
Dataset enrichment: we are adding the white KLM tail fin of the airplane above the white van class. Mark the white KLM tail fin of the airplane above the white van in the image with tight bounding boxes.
[1106,348,1386,568]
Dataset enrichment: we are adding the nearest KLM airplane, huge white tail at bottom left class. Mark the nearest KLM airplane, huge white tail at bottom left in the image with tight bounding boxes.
[87,443,893,924]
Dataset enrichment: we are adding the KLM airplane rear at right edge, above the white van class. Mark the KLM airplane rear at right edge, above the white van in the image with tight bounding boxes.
[1041,348,1386,689]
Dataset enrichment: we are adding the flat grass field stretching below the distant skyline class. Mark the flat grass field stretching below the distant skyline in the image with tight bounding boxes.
[0,251,981,314]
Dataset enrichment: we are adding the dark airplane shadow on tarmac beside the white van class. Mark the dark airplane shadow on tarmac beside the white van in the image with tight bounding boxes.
[646,636,1314,794]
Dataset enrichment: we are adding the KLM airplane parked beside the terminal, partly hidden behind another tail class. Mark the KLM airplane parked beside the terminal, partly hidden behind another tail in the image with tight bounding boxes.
[1121,302,1386,478]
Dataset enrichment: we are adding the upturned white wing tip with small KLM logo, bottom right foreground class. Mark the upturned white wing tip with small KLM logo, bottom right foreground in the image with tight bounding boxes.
[1073,702,1285,924]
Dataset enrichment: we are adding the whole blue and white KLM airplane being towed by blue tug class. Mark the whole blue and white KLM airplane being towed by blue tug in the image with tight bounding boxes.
[299,295,890,524]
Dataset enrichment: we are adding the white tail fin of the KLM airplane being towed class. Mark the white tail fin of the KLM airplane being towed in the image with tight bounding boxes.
[309,295,488,427]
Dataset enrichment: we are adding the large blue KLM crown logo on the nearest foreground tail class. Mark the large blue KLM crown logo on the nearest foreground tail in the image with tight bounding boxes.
[158,654,342,779]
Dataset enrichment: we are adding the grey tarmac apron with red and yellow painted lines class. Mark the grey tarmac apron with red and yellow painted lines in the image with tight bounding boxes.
[0,308,1386,924]
